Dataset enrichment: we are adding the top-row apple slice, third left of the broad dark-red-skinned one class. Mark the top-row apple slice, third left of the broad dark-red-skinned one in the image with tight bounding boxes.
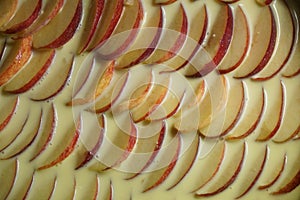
[116,7,165,69]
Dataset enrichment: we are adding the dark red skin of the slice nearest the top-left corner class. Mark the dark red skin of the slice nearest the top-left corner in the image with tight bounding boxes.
[4,0,42,34]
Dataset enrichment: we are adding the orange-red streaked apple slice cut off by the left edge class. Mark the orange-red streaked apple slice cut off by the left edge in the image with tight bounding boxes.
[0,36,32,86]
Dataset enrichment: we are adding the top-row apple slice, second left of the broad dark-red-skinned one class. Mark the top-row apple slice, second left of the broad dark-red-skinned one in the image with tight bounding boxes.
[144,4,188,64]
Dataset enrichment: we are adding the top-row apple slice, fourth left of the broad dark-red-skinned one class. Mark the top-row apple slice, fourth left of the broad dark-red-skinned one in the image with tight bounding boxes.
[96,0,144,60]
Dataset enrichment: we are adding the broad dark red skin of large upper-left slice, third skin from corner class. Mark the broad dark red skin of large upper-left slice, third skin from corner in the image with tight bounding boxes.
[39,0,83,49]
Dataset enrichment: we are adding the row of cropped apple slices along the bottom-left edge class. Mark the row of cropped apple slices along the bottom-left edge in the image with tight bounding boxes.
[0,159,113,200]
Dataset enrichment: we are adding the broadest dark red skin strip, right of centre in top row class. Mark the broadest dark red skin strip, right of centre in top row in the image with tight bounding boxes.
[187,5,233,78]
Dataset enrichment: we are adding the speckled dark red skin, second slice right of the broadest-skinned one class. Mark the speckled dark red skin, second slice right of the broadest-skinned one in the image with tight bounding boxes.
[234,7,277,78]
